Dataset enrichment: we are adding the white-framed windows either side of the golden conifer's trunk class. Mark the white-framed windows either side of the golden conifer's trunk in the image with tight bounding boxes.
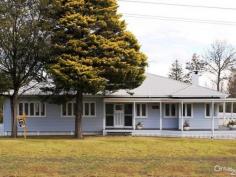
[61,101,96,117]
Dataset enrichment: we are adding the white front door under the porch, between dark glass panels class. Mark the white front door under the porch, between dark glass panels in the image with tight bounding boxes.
[114,104,124,128]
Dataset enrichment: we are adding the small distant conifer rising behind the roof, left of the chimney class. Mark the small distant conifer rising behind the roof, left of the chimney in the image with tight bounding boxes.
[169,60,184,82]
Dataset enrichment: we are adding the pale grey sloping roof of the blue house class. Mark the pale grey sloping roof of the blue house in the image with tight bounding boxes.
[109,73,227,98]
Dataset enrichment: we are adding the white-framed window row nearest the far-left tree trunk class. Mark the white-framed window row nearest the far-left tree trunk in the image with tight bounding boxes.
[18,102,46,117]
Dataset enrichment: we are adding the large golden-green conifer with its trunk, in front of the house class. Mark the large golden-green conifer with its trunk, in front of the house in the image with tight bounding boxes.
[49,0,147,138]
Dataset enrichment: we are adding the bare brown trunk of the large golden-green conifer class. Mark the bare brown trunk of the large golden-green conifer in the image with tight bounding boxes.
[75,91,83,139]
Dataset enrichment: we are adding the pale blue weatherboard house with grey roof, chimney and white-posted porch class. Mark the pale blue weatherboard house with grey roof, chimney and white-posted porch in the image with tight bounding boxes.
[4,73,236,135]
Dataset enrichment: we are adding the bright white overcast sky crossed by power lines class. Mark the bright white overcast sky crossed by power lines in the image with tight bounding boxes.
[119,0,236,87]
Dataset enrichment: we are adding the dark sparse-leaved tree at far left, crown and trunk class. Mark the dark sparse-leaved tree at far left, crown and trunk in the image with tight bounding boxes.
[0,0,48,137]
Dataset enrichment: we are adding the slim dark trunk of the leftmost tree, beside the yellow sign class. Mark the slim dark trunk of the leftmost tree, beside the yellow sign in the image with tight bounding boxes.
[10,93,18,138]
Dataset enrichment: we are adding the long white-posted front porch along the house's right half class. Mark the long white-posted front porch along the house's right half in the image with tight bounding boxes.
[103,98,236,137]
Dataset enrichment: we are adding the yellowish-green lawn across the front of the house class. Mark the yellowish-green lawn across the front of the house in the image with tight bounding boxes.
[0,137,236,177]
